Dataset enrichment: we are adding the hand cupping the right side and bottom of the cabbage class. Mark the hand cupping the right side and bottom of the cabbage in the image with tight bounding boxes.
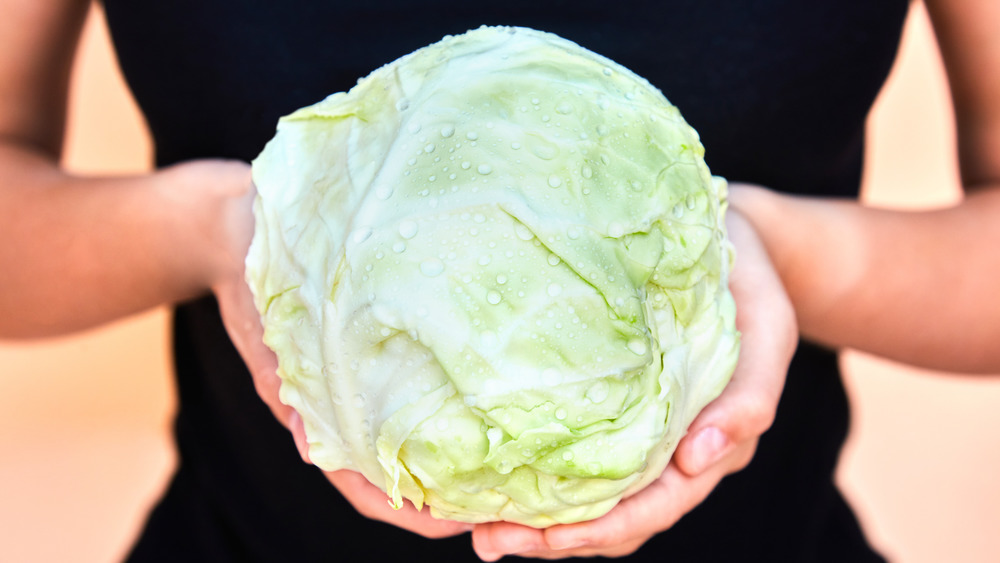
[472,206,798,561]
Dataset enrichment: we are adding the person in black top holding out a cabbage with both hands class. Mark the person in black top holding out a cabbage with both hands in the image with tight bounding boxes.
[0,0,1000,561]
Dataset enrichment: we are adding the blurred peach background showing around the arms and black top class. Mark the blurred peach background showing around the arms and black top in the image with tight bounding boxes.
[0,5,1000,563]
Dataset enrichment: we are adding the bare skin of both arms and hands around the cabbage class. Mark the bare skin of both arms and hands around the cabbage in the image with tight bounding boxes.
[0,0,1000,561]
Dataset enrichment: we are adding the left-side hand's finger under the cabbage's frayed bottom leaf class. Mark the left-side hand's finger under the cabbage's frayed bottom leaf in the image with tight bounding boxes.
[326,470,472,538]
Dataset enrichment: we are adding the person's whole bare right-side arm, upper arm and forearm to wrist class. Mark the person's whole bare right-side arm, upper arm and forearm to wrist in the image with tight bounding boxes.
[731,0,1000,372]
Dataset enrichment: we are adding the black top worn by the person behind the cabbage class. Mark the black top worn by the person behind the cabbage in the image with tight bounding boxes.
[104,0,908,563]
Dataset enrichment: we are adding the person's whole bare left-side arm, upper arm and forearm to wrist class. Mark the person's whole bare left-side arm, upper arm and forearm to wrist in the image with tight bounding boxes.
[0,0,249,337]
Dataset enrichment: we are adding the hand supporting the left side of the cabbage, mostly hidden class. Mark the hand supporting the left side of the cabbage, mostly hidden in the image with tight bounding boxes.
[213,178,471,538]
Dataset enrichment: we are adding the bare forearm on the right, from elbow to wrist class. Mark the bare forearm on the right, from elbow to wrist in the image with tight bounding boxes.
[732,188,1000,372]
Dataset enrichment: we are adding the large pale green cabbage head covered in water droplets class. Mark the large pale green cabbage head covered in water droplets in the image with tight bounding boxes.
[246,27,739,527]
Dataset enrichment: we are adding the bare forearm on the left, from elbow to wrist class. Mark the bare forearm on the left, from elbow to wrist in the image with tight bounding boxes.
[0,143,249,338]
